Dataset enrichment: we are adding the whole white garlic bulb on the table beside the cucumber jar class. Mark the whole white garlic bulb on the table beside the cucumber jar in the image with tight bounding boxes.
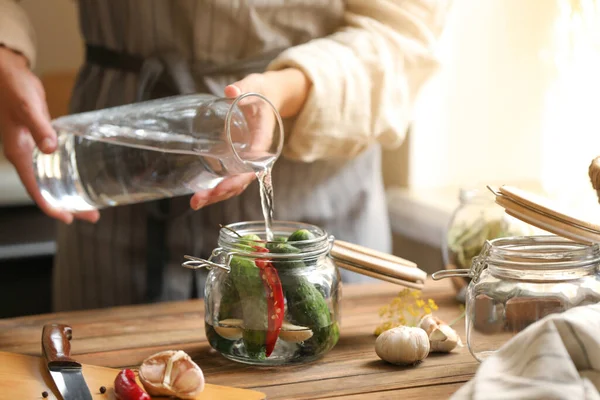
[375,326,429,365]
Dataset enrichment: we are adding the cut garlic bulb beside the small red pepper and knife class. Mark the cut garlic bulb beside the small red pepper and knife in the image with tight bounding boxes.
[139,350,204,399]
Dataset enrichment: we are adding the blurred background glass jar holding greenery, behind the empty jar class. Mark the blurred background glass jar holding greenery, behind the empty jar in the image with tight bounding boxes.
[442,188,532,301]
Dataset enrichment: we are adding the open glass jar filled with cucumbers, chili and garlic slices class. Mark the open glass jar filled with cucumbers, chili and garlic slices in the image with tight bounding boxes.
[188,221,341,365]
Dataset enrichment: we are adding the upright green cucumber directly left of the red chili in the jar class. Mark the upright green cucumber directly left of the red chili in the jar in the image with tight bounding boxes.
[230,257,268,360]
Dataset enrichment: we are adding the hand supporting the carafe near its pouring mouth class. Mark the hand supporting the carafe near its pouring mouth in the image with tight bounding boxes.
[190,68,310,210]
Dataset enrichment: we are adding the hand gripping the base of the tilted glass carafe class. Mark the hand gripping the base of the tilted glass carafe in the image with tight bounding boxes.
[0,45,99,224]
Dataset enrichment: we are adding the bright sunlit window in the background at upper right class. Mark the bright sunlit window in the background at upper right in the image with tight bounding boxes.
[409,0,600,217]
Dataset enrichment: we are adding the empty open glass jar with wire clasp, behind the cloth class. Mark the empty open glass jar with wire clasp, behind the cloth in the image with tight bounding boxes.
[433,235,600,361]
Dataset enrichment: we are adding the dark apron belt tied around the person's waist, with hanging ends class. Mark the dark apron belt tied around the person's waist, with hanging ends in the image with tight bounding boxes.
[85,44,283,302]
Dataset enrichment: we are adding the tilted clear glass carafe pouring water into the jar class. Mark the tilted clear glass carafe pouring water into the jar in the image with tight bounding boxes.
[33,93,284,212]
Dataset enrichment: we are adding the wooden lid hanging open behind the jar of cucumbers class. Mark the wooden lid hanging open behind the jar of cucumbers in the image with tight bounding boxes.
[330,239,427,289]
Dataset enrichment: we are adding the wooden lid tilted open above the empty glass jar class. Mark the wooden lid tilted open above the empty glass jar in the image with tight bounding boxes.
[488,185,600,244]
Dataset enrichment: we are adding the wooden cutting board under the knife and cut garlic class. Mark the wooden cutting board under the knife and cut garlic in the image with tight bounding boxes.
[0,352,266,400]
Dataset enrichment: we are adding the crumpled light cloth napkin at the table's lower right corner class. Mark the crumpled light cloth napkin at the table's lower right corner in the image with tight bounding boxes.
[451,304,600,400]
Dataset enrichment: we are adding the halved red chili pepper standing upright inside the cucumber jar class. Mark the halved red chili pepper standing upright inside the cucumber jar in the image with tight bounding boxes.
[254,246,284,357]
